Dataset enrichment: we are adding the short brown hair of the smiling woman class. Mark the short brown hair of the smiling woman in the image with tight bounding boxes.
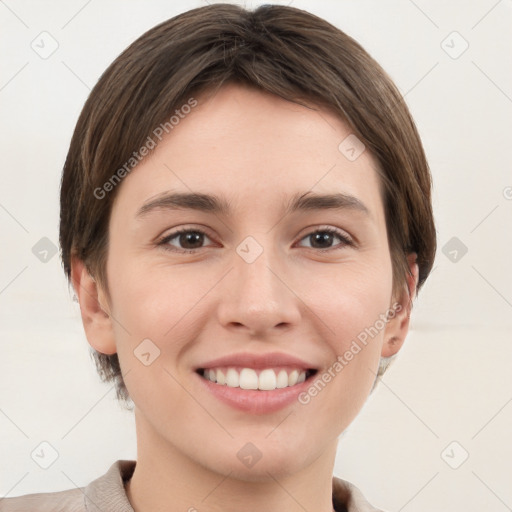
[60,4,436,406]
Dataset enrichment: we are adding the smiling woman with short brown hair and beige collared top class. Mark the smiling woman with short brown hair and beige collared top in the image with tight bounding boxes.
[1,4,436,512]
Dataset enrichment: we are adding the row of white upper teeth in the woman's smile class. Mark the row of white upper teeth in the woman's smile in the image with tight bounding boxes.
[203,368,306,391]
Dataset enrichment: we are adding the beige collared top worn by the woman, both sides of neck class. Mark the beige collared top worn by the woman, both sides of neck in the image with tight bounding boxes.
[0,460,382,512]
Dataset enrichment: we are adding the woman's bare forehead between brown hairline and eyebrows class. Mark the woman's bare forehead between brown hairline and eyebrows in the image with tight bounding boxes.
[116,84,382,220]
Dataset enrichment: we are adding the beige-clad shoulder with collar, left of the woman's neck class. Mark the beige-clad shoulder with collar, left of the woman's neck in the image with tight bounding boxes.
[0,460,136,512]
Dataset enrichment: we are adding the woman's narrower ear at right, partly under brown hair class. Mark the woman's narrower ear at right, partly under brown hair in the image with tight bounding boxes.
[381,253,419,357]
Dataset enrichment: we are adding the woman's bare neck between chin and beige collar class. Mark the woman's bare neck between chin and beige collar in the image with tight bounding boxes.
[126,409,337,512]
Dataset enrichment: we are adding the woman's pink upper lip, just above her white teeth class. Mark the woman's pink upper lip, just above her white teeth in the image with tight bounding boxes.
[196,352,316,370]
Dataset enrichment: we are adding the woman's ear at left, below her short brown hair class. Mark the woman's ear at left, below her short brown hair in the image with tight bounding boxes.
[71,256,117,354]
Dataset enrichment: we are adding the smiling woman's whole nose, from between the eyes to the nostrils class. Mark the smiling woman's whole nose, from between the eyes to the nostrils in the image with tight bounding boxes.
[220,236,298,331]
